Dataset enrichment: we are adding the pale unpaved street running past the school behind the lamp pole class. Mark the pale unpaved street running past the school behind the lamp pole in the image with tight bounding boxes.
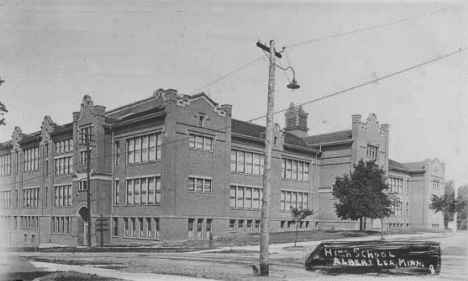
[1,232,468,280]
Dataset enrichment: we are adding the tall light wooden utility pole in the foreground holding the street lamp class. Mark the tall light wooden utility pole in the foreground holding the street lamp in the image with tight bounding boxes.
[257,40,281,276]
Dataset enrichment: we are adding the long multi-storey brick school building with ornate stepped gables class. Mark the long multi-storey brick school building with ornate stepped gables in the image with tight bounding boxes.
[0,89,444,245]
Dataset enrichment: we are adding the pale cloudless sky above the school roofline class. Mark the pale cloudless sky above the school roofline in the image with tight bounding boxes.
[0,1,468,185]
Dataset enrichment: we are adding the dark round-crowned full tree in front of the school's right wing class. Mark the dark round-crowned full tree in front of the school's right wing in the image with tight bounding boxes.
[333,159,394,231]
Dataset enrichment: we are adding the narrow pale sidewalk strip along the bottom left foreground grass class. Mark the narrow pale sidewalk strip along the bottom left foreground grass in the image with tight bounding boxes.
[31,261,215,281]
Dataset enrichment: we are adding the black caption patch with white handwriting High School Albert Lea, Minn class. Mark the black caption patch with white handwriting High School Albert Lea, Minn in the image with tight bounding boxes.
[305,241,441,275]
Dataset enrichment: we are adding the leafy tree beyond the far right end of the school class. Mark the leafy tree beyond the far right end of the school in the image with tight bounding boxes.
[429,180,467,229]
